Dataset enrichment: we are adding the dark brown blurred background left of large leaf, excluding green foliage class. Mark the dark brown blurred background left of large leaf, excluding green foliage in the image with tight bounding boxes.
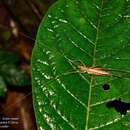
[0,0,56,130]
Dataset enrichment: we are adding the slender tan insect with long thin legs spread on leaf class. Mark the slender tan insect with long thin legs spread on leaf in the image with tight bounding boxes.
[38,45,130,80]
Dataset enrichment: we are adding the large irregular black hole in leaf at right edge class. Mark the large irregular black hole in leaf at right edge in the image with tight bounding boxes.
[106,98,130,115]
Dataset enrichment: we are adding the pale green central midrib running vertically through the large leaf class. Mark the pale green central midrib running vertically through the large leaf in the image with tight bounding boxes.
[85,0,103,130]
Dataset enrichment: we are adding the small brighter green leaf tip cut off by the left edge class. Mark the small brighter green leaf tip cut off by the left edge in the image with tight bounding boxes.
[0,76,7,97]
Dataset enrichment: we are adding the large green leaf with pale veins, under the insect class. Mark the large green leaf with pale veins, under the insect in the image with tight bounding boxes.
[32,0,130,130]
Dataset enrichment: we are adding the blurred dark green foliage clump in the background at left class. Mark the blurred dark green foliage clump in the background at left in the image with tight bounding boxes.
[0,51,30,96]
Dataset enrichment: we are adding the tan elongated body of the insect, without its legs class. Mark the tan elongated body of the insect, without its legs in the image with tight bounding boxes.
[79,66,112,76]
